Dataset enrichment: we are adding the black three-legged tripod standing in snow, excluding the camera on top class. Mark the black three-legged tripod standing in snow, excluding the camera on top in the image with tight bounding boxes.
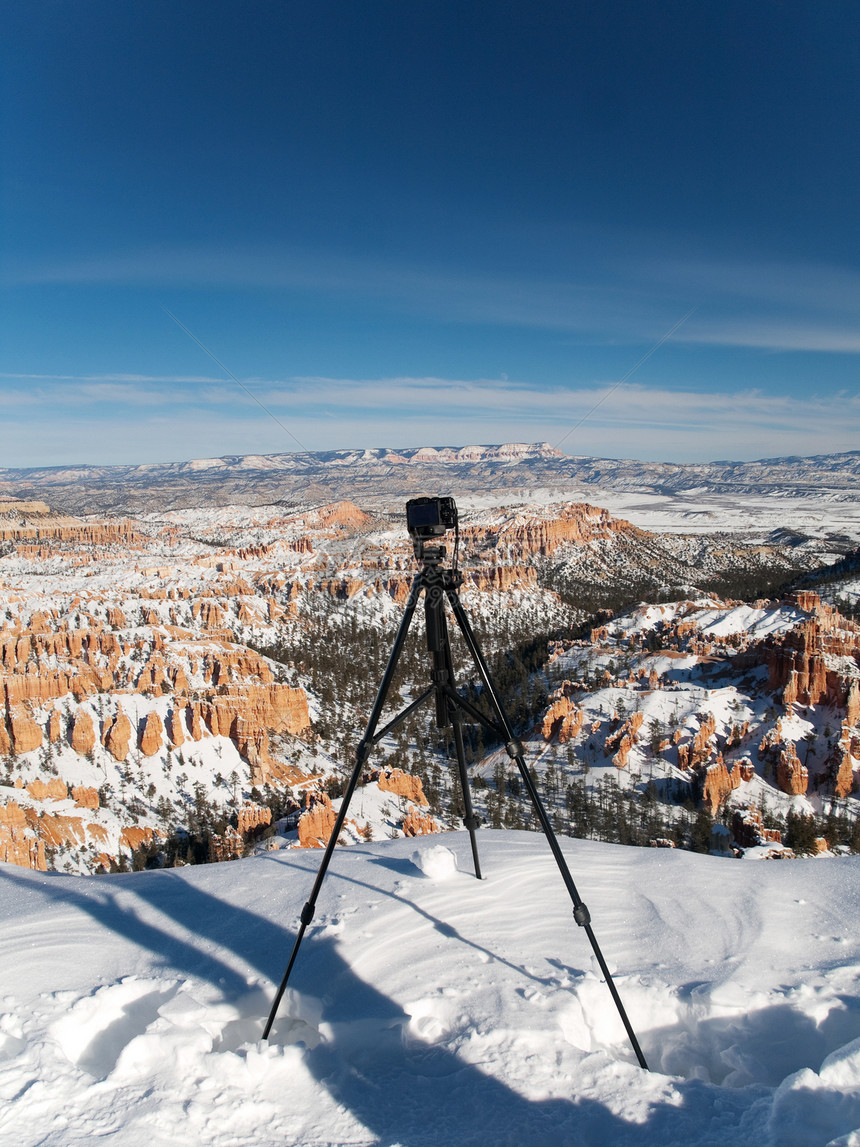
[263,539,648,1070]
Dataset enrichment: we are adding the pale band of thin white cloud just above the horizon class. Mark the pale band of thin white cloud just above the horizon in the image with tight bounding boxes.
[0,379,860,467]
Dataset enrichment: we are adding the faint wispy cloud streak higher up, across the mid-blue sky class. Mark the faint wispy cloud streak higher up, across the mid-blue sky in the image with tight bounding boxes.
[3,244,860,354]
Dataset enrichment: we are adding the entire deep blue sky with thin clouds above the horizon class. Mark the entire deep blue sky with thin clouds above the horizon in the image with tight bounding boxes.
[0,0,860,467]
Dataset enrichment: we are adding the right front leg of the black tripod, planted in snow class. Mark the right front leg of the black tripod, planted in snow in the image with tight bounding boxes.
[446,590,648,1071]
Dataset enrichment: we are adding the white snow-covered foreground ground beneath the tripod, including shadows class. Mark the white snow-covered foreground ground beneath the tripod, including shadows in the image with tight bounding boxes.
[0,830,860,1147]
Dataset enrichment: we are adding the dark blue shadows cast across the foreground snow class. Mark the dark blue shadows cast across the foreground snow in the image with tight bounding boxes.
[5,858,769,1147]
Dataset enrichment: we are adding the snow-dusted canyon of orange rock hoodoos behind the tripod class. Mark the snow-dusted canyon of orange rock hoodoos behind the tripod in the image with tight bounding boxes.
[0,446,860,872]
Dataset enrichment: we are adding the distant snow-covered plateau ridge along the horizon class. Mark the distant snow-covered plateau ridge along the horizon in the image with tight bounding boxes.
[0,443,860,523]
